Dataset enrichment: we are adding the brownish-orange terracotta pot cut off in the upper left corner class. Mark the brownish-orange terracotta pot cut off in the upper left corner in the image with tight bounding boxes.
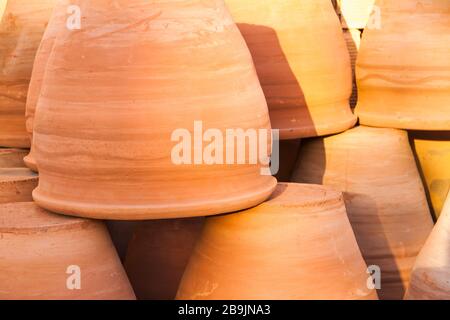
[0,0,56,148]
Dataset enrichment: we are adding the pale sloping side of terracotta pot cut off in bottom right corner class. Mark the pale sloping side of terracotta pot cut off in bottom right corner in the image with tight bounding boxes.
[405,195,450,300]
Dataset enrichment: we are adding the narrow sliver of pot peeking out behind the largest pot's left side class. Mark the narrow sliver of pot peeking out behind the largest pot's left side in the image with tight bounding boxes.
[23,0,70,172]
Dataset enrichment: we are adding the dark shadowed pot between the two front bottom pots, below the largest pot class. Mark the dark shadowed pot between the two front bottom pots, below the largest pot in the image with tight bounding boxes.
[125,218,204,300]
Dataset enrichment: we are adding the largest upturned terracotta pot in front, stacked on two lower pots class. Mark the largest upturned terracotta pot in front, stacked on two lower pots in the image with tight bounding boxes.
[33,0,276,220]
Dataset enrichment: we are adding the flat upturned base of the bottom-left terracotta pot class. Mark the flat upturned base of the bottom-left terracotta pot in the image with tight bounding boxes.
[0,202,94,234]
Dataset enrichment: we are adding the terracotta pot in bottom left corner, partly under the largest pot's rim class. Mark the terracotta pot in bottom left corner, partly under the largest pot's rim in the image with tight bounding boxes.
[0,202,135,300]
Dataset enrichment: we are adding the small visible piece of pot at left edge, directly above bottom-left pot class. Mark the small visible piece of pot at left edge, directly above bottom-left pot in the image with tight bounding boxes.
[0,168,39,203]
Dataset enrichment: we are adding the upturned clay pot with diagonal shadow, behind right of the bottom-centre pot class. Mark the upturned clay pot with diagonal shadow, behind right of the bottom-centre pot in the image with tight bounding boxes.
[292,126,433,299]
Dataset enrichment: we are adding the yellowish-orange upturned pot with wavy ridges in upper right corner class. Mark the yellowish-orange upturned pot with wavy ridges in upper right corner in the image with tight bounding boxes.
[356,0,450,130]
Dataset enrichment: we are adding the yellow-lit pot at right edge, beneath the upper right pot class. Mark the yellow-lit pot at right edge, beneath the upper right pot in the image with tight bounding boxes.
[409,131,450,219]
